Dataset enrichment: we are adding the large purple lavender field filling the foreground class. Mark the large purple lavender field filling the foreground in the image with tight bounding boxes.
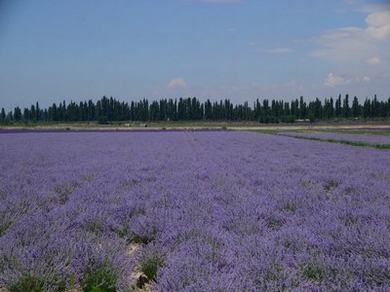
[0,131,390,292]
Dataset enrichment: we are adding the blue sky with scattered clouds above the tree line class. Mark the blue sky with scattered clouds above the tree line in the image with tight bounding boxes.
[0,0,390,108]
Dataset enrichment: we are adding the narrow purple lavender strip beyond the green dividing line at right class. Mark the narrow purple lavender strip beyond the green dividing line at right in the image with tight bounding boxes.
[280,132,390,145]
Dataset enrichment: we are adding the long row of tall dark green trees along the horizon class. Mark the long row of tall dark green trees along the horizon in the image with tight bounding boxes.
[0,94,390,123]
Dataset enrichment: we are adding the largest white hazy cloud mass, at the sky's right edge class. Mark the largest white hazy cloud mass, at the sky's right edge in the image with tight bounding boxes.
[311,6,390,95]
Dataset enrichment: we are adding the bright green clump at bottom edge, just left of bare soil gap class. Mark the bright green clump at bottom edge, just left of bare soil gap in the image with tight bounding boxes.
[83,265,117,292]
